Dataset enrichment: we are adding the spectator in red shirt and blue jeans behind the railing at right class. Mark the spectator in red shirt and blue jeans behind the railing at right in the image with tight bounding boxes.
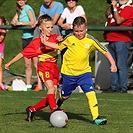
[105,0,133,93]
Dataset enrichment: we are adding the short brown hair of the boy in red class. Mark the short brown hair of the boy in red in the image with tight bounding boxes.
[37,14,53,26]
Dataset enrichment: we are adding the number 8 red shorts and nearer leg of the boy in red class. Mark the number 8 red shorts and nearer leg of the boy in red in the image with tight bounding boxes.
[38,67,59,112]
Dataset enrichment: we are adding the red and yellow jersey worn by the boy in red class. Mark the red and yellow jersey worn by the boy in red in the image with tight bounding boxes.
[21,34,58,62]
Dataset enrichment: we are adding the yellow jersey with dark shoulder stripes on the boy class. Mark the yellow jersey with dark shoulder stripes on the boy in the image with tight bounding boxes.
[58,34,108,76]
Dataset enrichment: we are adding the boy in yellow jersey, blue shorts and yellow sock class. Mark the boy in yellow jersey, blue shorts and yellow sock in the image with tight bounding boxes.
[41,17,117,125]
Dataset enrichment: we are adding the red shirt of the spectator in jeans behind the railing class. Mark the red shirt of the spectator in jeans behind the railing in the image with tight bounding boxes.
[105,4,133,42]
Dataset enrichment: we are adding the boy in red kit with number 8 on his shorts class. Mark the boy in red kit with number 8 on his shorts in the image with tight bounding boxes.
[5,15,60,122]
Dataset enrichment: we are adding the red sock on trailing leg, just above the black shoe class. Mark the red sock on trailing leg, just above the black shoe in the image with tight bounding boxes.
[29,98,48,112]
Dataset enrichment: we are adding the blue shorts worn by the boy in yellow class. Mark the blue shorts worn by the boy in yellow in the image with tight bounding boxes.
[61,72,95,96]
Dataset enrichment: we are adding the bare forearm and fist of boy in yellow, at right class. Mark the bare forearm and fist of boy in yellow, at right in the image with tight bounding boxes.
[105,51,117,72]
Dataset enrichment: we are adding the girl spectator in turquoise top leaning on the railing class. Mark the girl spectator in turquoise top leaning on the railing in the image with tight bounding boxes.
[11,0,42,90]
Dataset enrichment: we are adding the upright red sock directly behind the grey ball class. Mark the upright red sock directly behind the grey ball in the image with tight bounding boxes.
[47,94,56,112]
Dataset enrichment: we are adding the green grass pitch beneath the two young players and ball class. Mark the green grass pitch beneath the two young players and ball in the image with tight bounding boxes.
[0,91,133,133]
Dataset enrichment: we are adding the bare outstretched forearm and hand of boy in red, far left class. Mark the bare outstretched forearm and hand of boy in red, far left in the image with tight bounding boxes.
[5,53,23,70]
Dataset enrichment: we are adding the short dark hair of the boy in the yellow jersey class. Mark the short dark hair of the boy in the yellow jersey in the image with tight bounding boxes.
[73,16,86,27]
